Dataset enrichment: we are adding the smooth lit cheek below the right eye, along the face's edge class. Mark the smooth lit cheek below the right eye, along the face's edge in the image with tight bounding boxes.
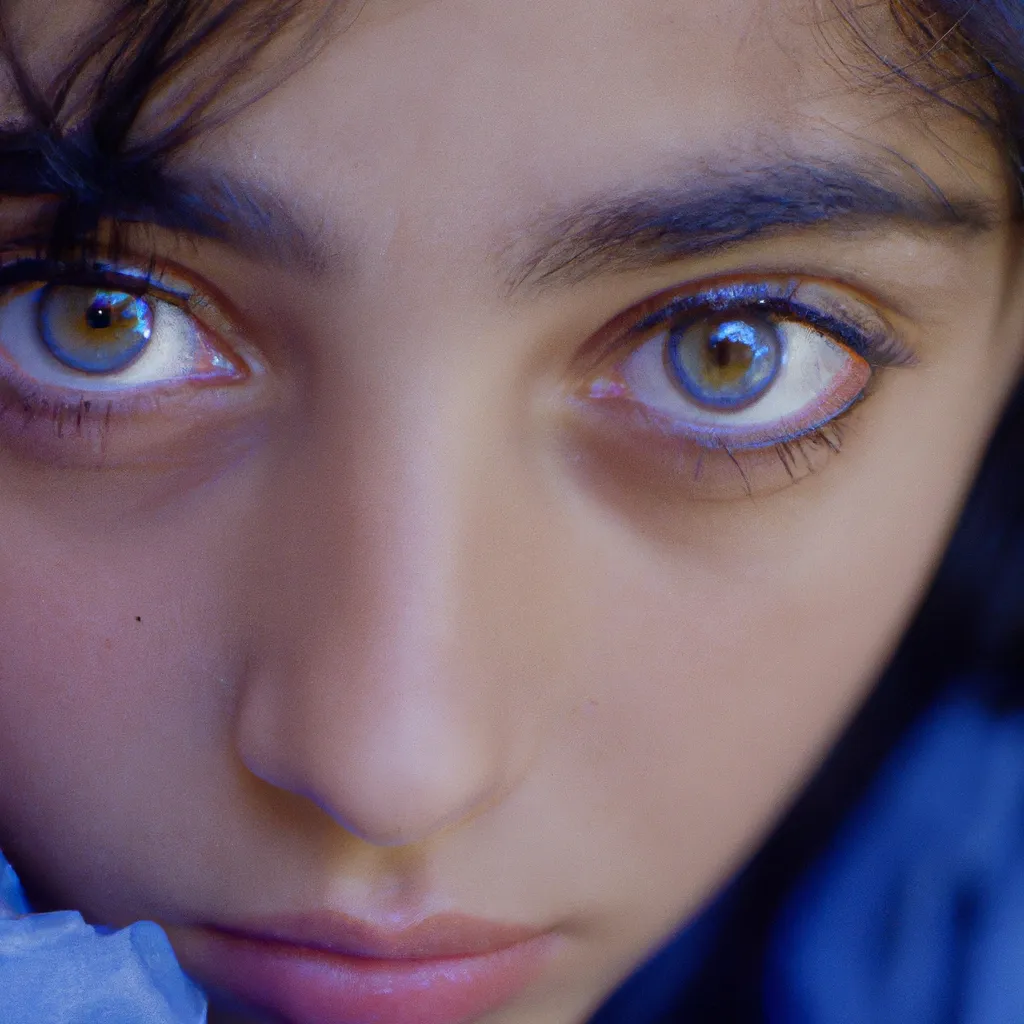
[540,356,998,928]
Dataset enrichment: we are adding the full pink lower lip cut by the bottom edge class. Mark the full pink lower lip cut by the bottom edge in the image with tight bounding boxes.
[174,929,553,1024]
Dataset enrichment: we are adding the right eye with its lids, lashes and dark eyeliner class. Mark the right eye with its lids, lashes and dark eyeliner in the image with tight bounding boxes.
[572,279,913,498]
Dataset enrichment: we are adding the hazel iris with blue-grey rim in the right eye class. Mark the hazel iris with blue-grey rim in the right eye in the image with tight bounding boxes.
[666,313,782,410]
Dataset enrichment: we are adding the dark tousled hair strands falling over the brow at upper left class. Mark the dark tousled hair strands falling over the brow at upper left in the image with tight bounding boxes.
[0,0,344,261]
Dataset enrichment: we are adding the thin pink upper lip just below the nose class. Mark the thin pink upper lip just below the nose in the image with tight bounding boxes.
[202,910,544,959]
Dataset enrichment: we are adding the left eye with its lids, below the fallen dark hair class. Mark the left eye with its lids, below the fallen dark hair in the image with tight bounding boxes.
[0,259,263,466]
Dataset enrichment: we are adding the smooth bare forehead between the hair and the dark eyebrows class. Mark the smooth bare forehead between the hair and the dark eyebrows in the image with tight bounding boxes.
[184,0,1002,276]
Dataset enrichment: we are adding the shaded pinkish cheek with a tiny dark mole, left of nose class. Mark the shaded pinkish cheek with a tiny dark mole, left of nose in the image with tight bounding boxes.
[0,471,244,908]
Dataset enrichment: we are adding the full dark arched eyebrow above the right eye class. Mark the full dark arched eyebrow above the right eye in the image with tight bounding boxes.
[502,162,1009,292]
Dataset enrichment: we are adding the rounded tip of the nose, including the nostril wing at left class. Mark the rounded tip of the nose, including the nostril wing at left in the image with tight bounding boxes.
[236,651,514,847]
